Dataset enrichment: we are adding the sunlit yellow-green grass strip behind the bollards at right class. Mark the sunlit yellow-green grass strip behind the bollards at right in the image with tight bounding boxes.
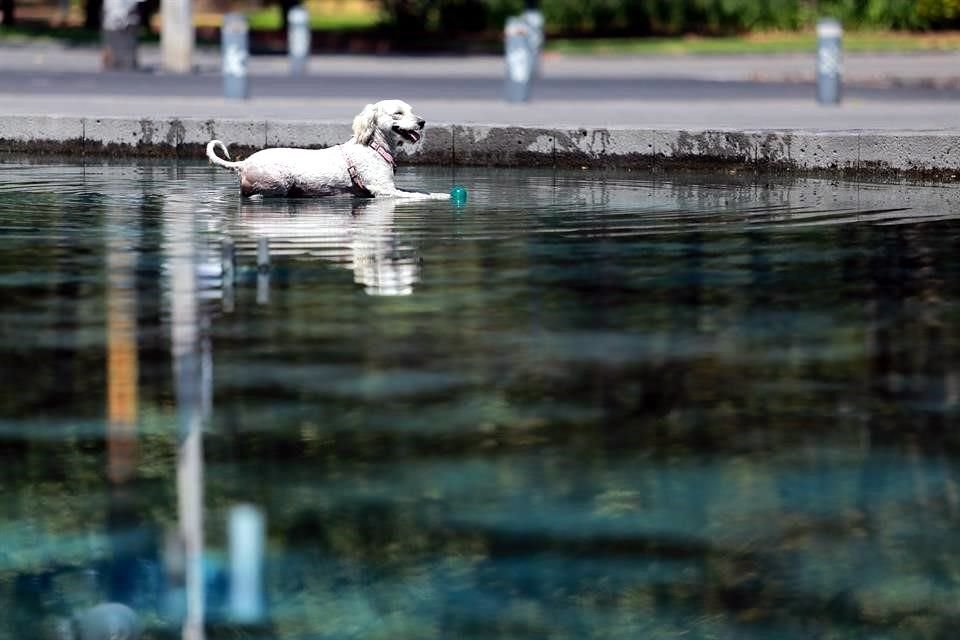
[546,31,960,55]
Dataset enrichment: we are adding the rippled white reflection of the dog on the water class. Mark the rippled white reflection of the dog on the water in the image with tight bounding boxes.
[233,198,420,296]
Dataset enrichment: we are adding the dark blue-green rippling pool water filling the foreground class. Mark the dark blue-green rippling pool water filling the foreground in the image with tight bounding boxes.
[0,158,960,640]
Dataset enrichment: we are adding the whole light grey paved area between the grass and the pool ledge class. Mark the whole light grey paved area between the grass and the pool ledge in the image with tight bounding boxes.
[0,46,960,129]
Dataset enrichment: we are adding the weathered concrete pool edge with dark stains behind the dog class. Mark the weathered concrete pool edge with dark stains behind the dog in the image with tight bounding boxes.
[0,116,960,181]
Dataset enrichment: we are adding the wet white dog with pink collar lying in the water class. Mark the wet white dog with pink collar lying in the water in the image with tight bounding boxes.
[207,100,450,199]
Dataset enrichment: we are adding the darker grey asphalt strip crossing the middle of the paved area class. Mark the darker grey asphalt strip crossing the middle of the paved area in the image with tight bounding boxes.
[0,68,960,105]
